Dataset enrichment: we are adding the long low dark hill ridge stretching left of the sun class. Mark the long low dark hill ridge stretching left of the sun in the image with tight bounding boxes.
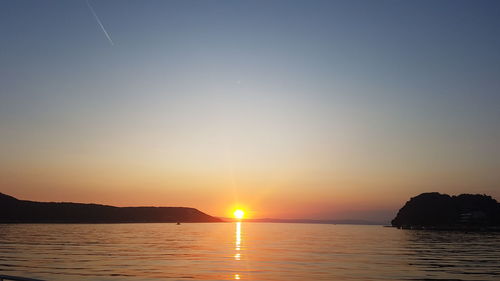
[0,193,221,223]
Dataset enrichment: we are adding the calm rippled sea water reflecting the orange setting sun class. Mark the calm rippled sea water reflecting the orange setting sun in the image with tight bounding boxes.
[0,223,500,281]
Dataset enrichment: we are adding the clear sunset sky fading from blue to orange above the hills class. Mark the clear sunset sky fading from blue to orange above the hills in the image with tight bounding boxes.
[0,0,500,220]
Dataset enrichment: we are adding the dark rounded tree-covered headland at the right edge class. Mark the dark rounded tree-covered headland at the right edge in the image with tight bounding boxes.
[392,192,500,227]
